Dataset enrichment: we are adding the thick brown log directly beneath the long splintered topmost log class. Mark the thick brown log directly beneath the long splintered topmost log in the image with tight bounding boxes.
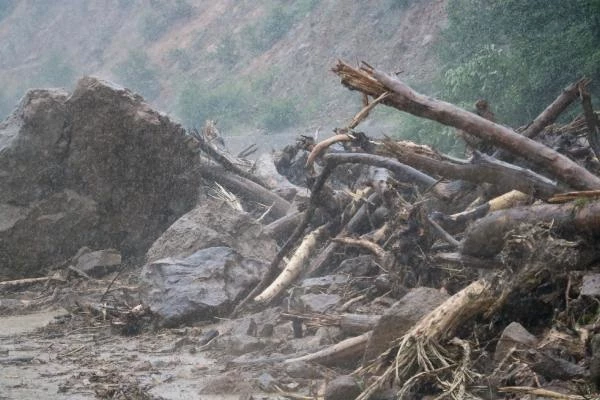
[384,139,560,199]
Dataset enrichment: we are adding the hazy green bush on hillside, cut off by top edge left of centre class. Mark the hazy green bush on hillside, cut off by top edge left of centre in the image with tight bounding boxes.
[140,0,194,41]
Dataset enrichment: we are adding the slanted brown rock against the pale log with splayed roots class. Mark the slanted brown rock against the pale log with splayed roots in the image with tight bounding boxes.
[363,287,449,365]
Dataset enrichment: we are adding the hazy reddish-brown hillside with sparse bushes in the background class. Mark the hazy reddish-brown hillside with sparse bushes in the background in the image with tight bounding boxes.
[0,0,447,138]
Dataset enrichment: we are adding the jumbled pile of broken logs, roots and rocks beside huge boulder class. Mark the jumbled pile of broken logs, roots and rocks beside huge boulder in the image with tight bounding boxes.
[0,62,600,400]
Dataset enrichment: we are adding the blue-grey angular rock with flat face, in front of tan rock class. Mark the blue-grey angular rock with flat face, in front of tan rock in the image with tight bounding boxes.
[141,247,267,327]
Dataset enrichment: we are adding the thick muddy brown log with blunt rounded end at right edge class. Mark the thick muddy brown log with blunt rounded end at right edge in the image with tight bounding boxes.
[461,200,600,257]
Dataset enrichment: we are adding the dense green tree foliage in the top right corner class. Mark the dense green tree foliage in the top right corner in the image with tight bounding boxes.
[438,0,600,126]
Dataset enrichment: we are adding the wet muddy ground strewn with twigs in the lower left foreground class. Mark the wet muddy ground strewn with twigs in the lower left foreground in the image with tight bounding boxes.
[0,272,314,399]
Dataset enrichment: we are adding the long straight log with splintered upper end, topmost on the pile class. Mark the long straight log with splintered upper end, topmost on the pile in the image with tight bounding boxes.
[333,61,600,190]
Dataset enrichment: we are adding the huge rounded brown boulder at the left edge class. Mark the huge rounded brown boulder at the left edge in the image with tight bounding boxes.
[0,77,199,278]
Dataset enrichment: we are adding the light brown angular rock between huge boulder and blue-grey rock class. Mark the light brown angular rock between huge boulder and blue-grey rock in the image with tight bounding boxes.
[146,200,277,262]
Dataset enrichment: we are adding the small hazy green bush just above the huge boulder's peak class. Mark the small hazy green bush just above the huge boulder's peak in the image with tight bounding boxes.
[113,50,160,100]
